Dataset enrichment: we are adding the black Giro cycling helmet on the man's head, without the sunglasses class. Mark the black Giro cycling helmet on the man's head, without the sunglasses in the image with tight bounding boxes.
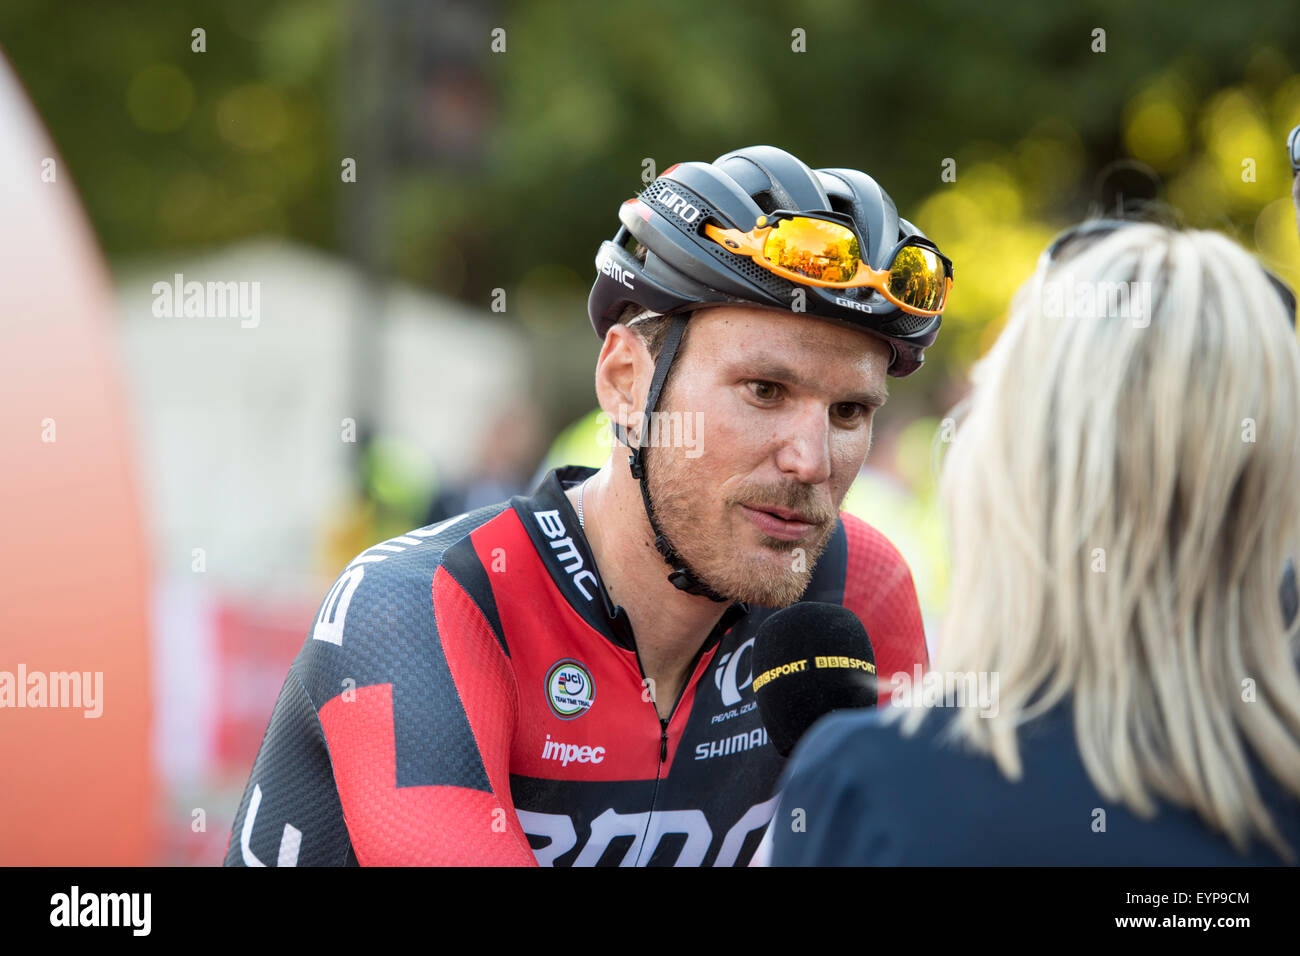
[588,146,940,377]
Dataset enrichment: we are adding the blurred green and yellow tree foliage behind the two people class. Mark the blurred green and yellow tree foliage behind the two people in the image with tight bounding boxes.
[0,0,1300,425]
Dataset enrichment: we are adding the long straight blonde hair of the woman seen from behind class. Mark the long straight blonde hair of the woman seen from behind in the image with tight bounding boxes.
[901,224,1300,861]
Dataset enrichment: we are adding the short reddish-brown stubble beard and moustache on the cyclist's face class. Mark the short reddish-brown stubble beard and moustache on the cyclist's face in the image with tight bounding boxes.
[645,434,836,607]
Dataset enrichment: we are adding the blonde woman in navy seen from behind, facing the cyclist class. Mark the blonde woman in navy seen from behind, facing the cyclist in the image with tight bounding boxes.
[771,222,1300,865]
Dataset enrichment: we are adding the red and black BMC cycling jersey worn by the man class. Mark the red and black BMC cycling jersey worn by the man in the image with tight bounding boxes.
[226,467,927,866]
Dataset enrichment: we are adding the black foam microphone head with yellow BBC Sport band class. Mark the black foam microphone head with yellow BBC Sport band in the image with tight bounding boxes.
[753,601,878,757]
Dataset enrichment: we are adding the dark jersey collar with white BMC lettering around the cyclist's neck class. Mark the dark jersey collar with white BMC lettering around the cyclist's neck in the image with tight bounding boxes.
[510,464,749,650]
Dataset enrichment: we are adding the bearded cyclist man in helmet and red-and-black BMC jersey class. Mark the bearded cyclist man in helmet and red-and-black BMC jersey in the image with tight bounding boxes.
[226,146,952,865]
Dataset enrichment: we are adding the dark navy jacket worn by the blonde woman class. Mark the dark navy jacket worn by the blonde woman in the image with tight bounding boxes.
[771,704,1300,866]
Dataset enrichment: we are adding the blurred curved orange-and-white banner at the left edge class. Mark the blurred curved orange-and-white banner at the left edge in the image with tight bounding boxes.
[0,59,153,865]
